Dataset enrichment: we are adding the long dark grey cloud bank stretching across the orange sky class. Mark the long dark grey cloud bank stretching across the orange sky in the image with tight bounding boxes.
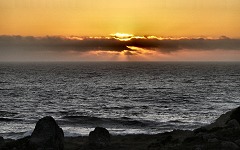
[0,35,240,53]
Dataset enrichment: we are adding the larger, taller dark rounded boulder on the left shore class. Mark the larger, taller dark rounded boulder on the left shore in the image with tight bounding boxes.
[29,116,64,150]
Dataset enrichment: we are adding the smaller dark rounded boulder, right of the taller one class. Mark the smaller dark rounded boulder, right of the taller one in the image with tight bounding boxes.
[89,127,110,147]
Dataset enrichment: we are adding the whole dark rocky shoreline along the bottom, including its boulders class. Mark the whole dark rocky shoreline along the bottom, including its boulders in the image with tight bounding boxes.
[0,107,240,150]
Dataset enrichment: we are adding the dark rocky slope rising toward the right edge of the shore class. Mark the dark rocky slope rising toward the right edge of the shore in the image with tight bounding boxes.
[148,107,240,150]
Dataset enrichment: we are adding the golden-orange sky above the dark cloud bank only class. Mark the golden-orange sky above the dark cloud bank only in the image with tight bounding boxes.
[0,0,240,37]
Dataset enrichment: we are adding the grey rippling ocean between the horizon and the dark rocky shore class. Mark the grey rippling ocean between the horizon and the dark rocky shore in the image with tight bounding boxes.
[0,62,240,139]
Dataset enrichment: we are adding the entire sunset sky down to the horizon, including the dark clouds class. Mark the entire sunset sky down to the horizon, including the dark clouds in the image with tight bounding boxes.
[0,0,240,61]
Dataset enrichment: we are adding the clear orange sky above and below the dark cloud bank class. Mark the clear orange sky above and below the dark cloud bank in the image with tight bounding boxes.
[0,0,240,61]
